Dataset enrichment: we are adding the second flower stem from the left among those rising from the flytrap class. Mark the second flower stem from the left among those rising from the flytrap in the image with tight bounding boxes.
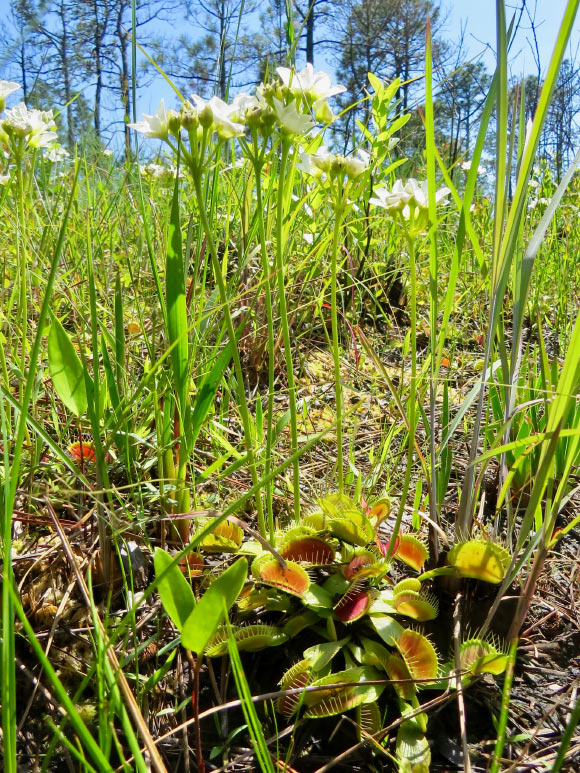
[253,148,275,544]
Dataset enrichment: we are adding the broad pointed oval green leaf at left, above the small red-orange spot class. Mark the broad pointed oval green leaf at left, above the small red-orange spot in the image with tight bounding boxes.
[48,317,92,417]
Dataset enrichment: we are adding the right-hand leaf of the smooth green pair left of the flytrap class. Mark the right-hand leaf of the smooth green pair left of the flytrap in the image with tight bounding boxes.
[181,558,248,654]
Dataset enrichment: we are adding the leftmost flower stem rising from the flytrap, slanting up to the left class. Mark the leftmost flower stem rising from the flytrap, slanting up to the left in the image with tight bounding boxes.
[191,165,266,537]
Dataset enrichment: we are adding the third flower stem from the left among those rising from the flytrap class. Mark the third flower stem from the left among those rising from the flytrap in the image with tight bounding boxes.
[276,137,300,519]
